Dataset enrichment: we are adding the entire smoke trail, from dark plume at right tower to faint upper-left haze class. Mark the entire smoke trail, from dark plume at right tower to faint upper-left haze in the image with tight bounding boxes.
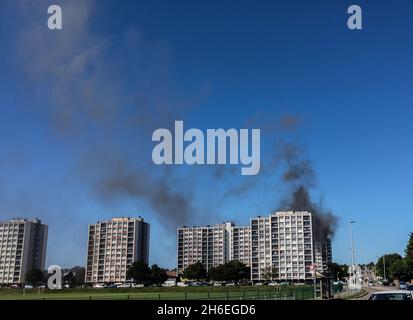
[0,0,337,266]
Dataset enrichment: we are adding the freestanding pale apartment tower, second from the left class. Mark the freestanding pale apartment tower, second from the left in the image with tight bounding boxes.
[85,217,150,283]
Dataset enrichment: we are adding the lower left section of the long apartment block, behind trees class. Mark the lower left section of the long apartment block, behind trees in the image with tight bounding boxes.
[178,222,250,274]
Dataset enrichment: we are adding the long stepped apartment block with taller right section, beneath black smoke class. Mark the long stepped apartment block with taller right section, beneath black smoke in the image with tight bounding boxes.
[178,211,332,282]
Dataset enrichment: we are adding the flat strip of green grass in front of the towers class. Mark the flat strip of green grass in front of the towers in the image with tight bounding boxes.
[0,286,314,300]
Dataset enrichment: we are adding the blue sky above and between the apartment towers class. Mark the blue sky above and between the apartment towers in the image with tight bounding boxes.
[0,0,413,267]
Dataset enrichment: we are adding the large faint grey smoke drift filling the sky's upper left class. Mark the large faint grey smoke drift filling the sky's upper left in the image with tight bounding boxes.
[12,0,208,228]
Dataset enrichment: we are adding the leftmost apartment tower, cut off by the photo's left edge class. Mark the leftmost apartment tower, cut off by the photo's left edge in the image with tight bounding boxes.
[0,218,48,284]
